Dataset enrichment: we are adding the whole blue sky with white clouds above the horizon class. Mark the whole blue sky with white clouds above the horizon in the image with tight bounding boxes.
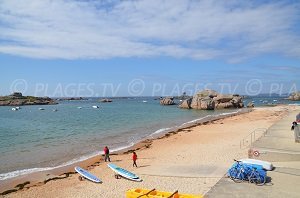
[0,0,300,97]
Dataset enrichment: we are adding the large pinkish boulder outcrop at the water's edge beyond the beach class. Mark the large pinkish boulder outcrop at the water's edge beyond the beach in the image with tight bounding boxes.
[180,90,244,110]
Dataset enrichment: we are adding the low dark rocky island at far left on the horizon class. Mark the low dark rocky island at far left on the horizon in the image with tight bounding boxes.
[0,92,58,106]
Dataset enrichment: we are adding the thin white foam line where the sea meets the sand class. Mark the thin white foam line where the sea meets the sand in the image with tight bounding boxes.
[0,110,241,181]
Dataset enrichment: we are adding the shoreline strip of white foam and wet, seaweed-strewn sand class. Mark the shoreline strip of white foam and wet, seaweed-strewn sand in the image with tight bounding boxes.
[0,108,251,195]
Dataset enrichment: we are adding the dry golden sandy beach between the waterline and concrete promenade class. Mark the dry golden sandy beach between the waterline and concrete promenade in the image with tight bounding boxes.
[4,106,299,198]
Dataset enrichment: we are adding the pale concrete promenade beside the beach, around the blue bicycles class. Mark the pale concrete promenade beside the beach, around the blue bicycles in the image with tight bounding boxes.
[205,108,300,198]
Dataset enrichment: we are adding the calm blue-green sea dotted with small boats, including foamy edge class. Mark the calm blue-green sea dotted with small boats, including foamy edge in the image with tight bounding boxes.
[0,97,299,180]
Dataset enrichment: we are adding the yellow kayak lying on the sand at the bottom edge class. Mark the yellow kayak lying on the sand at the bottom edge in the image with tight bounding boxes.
[126,188,203,198]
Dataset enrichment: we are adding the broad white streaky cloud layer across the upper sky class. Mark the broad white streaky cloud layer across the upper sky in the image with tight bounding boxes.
[0,0,300,61]
